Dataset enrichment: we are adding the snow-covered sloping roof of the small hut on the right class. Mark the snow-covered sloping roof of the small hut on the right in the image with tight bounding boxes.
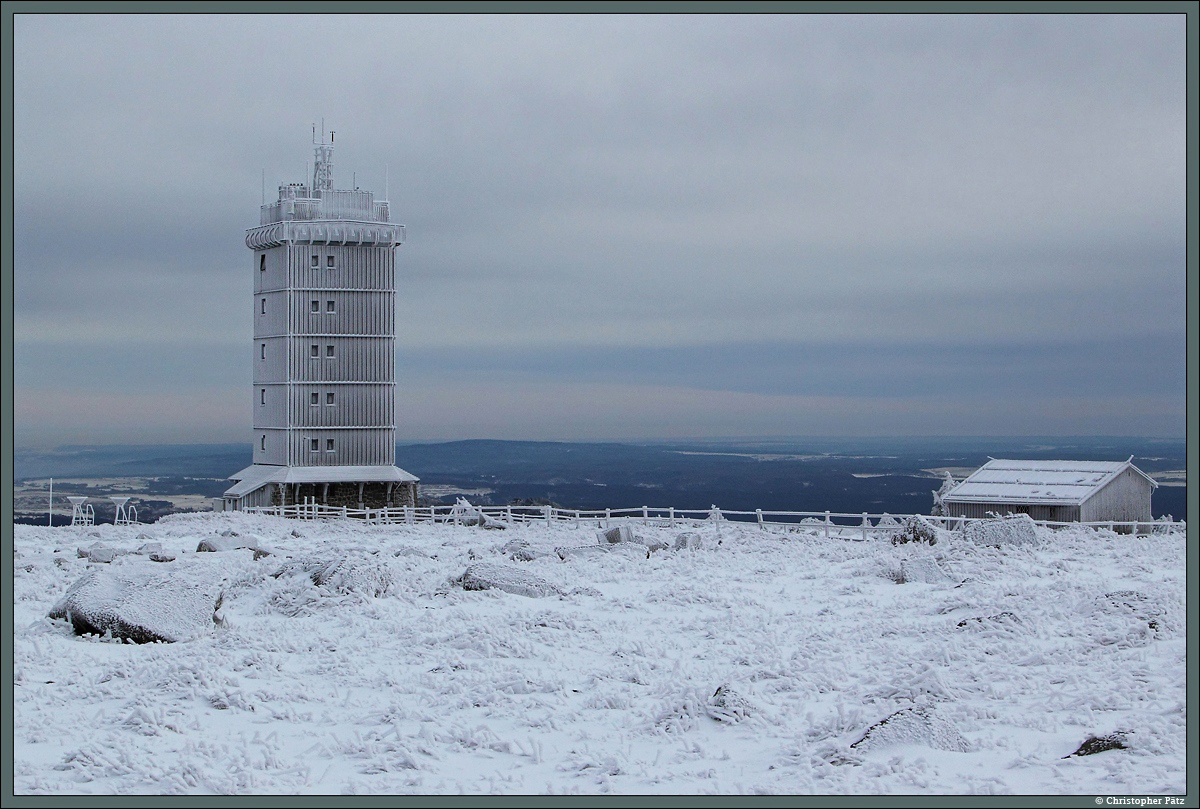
[942,459,1157,505]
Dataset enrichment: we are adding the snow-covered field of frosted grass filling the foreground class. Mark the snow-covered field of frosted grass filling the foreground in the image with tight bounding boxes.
[12,514,1187,795]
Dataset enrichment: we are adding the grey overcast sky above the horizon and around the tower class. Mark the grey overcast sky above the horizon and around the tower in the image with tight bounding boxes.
[13,14,1187,447]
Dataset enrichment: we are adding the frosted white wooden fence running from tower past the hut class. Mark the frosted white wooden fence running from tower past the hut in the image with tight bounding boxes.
[238,498,1187,540]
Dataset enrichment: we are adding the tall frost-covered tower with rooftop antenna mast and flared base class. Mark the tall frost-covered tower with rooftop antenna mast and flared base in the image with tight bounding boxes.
[222,127,418,510]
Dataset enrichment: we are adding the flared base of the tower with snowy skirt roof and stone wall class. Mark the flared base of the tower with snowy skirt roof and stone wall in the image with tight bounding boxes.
[222,463,418,511]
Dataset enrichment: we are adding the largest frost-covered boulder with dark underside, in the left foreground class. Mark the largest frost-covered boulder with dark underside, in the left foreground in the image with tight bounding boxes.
[49,568,221,643]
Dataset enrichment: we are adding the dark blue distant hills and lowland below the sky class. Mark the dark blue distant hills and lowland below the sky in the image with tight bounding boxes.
[13,437,1187,519]
